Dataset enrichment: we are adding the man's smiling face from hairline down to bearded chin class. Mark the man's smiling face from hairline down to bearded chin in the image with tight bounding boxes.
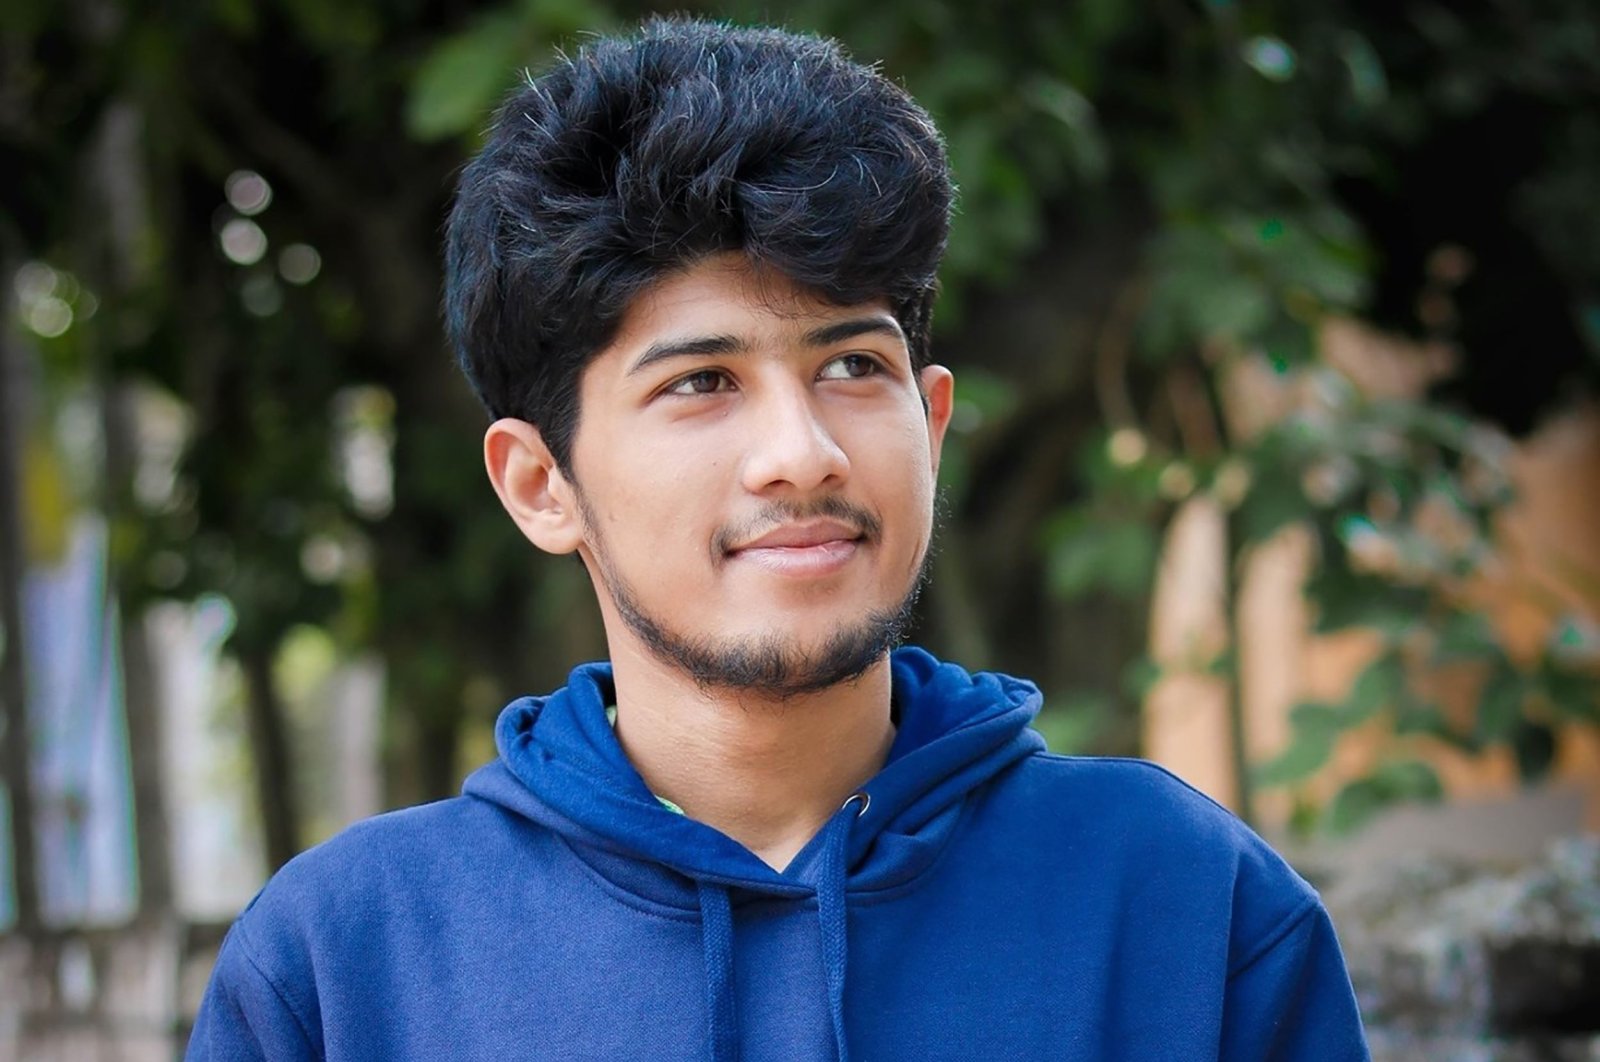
[570,254,950,694]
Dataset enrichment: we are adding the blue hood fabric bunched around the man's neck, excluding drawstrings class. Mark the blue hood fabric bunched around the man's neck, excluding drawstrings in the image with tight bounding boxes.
[464,648,1045,907]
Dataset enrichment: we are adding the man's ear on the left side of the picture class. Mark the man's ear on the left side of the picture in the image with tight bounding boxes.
[483,417,584,553]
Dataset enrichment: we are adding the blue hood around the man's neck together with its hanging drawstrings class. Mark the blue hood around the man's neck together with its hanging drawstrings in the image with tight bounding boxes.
[466,649,1045,1062]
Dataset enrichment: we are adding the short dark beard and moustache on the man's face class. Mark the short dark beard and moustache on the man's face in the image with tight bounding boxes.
[578,491,933,699]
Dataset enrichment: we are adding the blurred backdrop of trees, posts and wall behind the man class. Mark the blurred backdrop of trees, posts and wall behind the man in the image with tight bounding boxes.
[0,0,1600,1059]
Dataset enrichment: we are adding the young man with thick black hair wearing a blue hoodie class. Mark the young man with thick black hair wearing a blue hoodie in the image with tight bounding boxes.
[190,21,1366,1062]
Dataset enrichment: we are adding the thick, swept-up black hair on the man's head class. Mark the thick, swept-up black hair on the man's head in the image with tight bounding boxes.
[445,19,954,470]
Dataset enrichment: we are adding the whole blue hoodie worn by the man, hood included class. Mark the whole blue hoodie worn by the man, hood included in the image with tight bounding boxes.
[189,649,1366,1062]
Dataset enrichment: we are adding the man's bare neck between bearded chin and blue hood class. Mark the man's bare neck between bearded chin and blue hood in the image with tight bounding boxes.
[611,643,894,870]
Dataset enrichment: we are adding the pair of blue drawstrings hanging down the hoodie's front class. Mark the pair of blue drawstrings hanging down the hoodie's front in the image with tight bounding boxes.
[699,793,872,1062]
